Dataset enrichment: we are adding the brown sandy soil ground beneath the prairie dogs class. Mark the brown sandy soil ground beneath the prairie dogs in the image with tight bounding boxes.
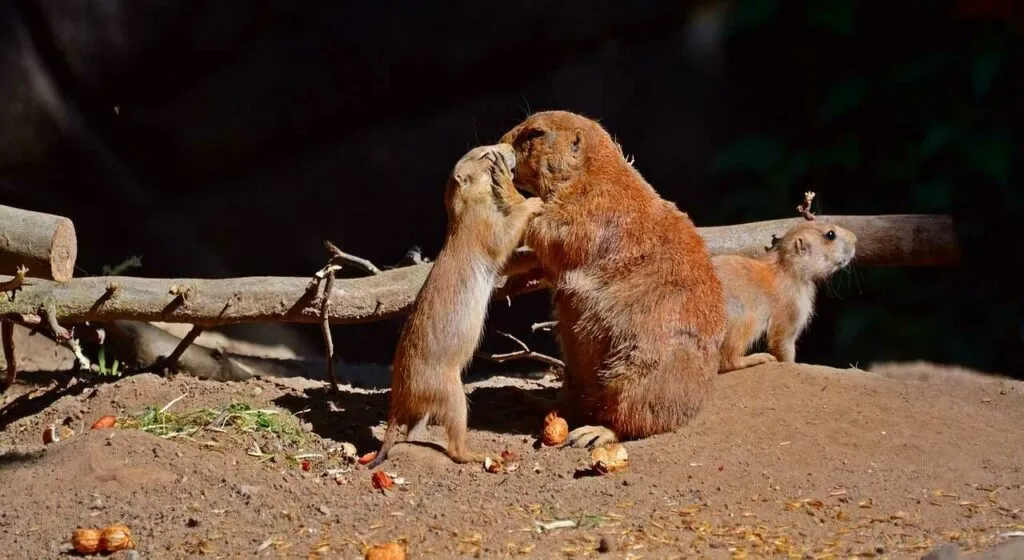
[0,323,1024,559]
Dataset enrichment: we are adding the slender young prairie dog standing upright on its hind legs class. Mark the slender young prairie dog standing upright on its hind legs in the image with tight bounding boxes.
[369,144,542,469]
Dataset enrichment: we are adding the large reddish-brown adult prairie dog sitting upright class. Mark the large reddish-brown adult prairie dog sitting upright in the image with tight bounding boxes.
[501,112,725,446]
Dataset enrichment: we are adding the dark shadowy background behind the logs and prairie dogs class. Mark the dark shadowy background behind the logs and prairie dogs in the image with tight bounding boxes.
[0,0,1024,377]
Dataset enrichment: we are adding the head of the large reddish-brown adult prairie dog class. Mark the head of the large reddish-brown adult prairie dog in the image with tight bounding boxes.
[501,111,625,202]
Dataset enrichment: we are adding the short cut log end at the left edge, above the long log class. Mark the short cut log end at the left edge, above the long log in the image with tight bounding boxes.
[0,205,78,282]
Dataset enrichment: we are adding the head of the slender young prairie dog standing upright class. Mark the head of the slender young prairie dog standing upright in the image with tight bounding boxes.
[444,143,516,221]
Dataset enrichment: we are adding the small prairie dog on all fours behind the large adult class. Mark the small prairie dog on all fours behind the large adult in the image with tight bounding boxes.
[712,220,857,374]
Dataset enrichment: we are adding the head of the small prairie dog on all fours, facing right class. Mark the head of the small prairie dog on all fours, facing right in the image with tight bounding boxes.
[775,221,857,281]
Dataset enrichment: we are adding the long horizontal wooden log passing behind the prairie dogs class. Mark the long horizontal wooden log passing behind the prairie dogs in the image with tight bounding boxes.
[0,215,959,327]
